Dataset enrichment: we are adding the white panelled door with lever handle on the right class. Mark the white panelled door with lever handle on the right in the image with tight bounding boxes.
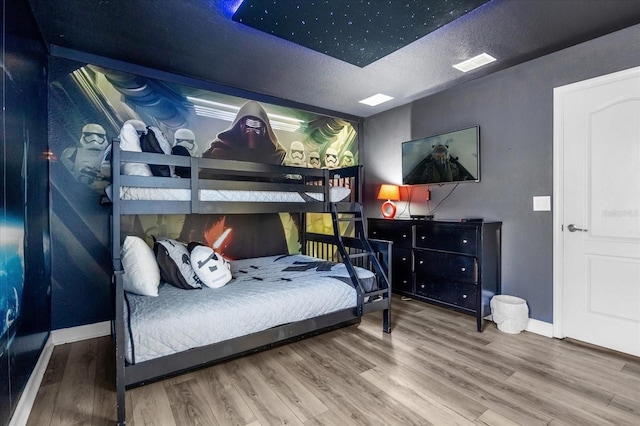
[554,68,640,356]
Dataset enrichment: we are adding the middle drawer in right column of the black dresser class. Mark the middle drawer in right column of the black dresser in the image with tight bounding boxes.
[415,250,478,284]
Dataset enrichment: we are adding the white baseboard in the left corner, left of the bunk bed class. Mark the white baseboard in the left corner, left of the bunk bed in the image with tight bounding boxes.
[9,321,111,426]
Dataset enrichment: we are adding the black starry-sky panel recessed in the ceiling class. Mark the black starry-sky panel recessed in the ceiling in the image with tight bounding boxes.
[233,0,489,67]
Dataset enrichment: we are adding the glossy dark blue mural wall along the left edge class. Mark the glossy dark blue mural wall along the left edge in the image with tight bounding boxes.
[0,0,51,425]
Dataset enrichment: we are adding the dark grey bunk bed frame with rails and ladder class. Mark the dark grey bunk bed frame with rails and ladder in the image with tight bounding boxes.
[111,139,391,425]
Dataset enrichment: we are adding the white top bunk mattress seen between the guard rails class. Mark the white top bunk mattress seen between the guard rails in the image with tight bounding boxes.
[106,186,351,203]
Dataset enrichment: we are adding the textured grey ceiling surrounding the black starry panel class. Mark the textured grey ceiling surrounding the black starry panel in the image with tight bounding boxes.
[28,0,640,117]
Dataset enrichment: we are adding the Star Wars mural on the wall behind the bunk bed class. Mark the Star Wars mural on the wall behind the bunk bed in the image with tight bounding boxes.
[49,58,358,328]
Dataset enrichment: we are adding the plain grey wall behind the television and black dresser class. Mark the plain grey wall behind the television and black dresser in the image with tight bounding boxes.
[362,25,640,322]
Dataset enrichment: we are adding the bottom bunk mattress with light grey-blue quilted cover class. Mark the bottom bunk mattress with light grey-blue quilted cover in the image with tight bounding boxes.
[124,255,376,364]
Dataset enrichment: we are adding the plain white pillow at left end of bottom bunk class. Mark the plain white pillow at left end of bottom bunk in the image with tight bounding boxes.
[121,235,160,296]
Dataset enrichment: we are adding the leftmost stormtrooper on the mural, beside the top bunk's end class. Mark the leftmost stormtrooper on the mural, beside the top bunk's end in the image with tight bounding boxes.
[60,123,109,191]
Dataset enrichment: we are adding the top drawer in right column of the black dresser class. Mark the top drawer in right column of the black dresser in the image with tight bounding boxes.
[416,223,478,254]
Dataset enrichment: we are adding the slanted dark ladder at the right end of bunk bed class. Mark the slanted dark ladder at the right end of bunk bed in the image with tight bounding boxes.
[331,202,391,333]
